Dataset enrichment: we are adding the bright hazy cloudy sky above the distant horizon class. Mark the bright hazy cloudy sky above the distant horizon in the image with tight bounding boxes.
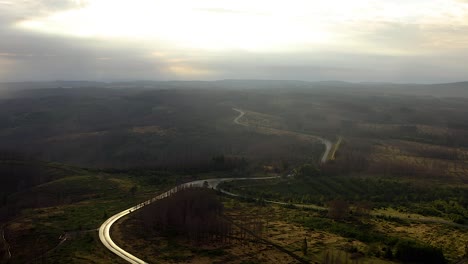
[0,0,468,83]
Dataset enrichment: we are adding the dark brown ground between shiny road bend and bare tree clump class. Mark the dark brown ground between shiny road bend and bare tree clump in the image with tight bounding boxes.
[111,212,298,264]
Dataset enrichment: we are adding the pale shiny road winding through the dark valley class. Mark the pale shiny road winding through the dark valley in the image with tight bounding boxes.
[99,108,332,264]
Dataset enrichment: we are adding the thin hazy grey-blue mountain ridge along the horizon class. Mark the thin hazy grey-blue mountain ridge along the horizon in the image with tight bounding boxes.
[0,79,468,98]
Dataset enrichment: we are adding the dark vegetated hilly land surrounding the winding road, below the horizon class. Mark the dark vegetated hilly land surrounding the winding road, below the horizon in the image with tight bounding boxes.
[0,87,468,263]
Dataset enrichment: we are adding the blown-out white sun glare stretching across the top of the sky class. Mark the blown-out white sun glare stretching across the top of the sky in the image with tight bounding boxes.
[13,0,468,52]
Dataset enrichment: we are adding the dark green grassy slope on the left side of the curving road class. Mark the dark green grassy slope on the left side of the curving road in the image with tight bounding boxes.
[0,161,191,263]
